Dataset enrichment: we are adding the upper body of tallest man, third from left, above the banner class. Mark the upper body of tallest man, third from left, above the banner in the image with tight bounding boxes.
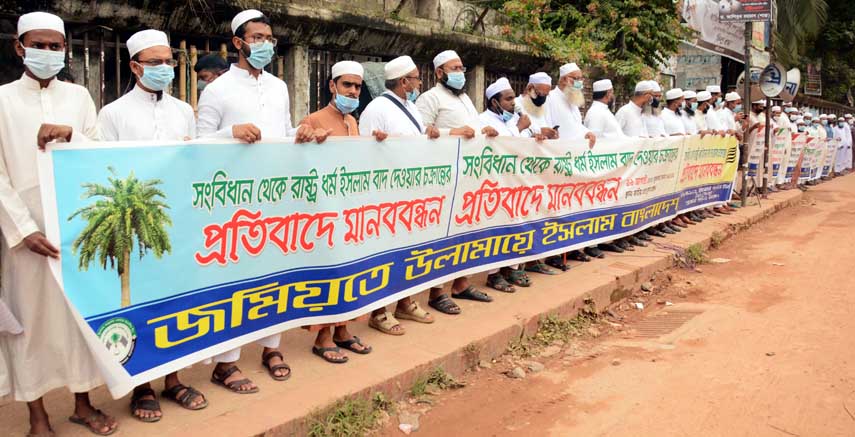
[197,9,326,143]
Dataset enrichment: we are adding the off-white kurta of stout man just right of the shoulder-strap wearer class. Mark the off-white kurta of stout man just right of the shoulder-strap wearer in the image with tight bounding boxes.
[416,83,481,135]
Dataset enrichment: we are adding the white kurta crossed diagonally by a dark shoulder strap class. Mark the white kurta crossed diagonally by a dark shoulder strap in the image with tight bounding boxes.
[359,90,424,137]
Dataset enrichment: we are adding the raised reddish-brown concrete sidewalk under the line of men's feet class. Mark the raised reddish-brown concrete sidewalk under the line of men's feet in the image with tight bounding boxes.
[0,188,804,436]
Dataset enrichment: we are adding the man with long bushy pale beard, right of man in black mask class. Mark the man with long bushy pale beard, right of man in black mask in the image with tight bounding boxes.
[546,63,597,146]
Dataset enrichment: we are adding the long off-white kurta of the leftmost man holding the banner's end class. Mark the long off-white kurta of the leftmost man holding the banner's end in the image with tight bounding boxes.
[0,76,101,401]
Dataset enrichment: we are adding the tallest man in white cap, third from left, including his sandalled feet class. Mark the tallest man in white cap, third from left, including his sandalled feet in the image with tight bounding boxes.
[204,9,300,394]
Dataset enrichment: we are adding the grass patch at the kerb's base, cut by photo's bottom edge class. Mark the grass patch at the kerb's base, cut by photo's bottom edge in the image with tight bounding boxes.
[308,392,394,437]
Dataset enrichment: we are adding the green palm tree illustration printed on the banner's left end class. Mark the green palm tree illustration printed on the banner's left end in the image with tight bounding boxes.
[68,167,172,308]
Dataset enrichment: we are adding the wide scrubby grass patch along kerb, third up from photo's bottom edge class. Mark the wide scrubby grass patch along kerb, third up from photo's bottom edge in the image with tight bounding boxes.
[508,307,600,358]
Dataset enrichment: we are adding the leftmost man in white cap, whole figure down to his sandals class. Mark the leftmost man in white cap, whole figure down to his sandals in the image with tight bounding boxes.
[0,12,117,435]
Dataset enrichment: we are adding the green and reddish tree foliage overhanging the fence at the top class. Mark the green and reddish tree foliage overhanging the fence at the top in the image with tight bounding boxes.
[493,0,691,80]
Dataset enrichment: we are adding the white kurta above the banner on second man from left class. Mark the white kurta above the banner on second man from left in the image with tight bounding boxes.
[98,86,196,141]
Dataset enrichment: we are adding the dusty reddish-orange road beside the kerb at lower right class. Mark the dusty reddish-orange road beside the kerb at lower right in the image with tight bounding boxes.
[386,176,855,437]
